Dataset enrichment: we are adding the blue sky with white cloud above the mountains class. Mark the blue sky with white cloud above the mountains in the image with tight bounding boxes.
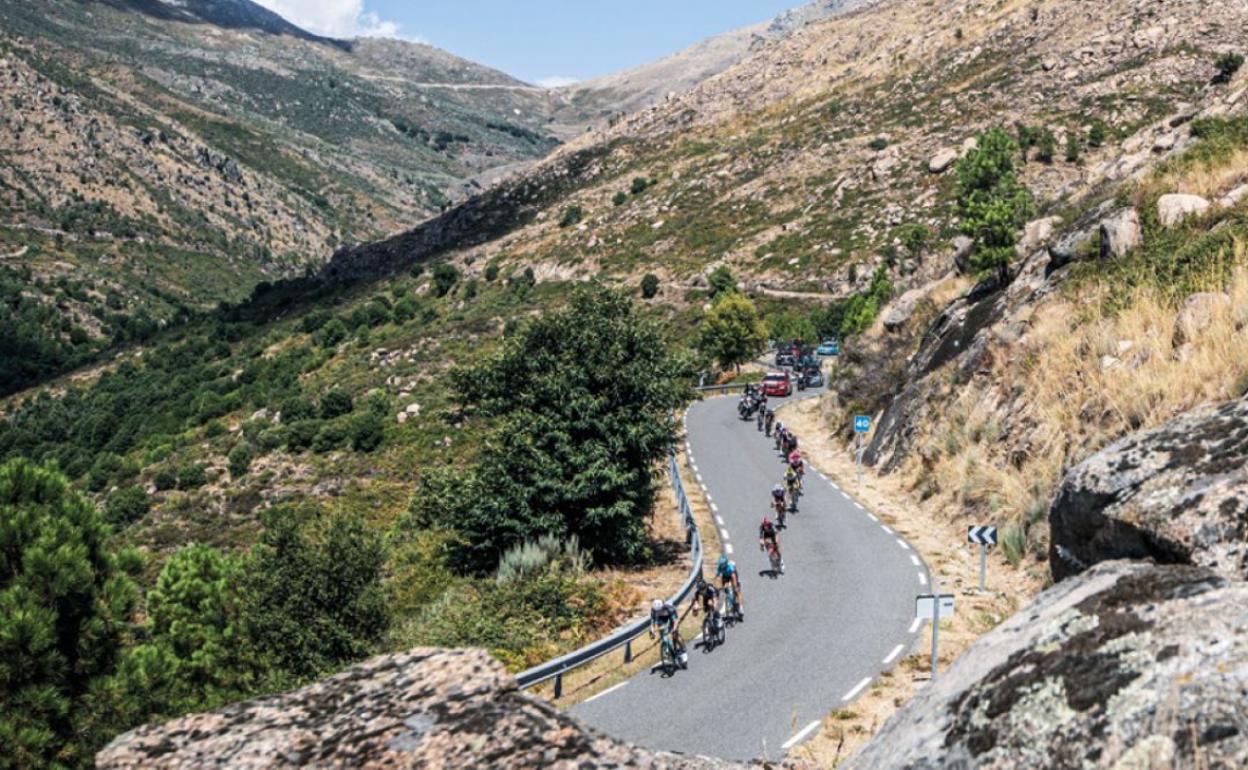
[256,0,802,85]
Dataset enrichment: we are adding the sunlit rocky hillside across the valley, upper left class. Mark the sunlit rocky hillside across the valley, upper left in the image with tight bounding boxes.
[0,0,557,392]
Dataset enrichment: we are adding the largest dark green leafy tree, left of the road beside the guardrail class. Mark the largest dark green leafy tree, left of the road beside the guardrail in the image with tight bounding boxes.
[411,287,690,572]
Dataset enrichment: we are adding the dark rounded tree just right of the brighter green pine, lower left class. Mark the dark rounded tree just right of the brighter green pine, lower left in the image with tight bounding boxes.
[241,508,388,679]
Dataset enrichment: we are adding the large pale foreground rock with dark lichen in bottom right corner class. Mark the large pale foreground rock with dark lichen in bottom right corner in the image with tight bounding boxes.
[847,562,1248,770]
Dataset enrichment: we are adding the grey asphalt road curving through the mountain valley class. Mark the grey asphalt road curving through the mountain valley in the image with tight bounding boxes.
[573,397,927,760]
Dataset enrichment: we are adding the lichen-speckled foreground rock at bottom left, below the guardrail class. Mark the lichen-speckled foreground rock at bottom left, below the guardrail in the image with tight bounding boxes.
[96,649,741,770]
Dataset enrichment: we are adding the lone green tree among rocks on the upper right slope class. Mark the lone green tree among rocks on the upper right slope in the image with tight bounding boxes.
[957,126,1035,283]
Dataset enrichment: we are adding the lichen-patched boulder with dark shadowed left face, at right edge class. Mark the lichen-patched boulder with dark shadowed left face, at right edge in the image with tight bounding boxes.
[1048,399,1248,579]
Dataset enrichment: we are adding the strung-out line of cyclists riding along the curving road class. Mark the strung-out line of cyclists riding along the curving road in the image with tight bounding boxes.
[650,388,806,668]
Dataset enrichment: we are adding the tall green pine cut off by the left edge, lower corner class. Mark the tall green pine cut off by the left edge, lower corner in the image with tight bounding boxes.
[0,459,137,768]
